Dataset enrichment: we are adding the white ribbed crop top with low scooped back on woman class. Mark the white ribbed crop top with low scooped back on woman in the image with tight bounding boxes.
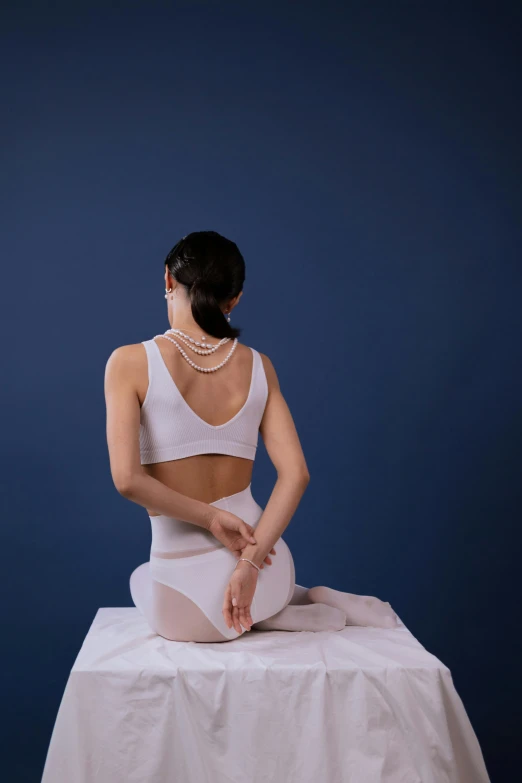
[140,340,268,465]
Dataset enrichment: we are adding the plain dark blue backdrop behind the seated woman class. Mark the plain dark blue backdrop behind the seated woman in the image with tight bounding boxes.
[0,2,522,783]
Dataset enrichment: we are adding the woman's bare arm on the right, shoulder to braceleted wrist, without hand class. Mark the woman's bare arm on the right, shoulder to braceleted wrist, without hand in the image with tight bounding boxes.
[236,354,310,570]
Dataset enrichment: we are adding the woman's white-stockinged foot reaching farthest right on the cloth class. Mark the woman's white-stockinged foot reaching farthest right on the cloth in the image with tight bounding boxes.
[308,585,398,628]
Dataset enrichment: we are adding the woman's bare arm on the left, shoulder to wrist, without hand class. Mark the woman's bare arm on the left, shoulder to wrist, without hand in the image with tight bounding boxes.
[105,344,216,530]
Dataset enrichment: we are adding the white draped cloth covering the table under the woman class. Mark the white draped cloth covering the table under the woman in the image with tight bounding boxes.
[42,607,489,783]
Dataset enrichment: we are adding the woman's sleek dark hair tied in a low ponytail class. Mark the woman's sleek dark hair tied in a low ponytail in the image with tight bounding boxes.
[165,231,245,338]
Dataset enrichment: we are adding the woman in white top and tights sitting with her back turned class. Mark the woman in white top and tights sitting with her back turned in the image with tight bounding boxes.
[105,231,397,642]
